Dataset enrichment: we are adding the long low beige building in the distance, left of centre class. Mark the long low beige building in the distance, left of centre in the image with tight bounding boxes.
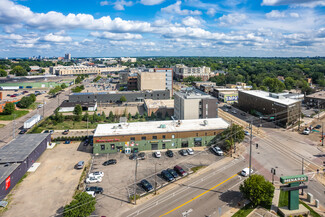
[50,66,126,75]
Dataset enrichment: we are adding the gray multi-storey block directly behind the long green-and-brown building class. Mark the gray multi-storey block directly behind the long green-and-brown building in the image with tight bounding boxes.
[174,88,218,120]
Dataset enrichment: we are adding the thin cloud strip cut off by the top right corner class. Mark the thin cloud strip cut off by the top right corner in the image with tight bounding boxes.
[261,0,325,8]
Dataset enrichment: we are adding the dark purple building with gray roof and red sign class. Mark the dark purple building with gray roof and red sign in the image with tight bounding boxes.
[0,133,51,200]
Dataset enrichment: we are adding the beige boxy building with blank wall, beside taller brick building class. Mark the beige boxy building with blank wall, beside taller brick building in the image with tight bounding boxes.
[138,72,166,90]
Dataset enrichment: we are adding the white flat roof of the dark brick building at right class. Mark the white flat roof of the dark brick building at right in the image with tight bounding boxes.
[239,90,300,105]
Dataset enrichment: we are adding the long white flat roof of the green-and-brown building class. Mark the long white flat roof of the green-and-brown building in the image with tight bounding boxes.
[94,118,229,137]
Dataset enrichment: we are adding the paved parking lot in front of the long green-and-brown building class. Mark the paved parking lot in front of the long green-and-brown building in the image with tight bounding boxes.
[88,148,223,216]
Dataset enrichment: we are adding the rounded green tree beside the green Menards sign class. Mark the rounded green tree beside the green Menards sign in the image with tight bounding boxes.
[239,174,274,206]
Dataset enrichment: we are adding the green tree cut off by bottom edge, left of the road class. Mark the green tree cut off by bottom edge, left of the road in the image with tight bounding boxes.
[63,192,96,217]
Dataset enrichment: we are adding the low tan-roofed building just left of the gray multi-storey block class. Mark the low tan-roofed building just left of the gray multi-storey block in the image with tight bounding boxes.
[144,99,174,118]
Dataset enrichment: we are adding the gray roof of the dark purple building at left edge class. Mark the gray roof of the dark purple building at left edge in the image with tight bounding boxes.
[0,133,49,165]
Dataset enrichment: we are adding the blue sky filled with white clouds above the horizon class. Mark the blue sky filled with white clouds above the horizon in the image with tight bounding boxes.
[0,0,325,57]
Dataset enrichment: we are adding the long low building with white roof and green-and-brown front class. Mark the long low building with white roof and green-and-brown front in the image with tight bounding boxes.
[93,118,229,154]
